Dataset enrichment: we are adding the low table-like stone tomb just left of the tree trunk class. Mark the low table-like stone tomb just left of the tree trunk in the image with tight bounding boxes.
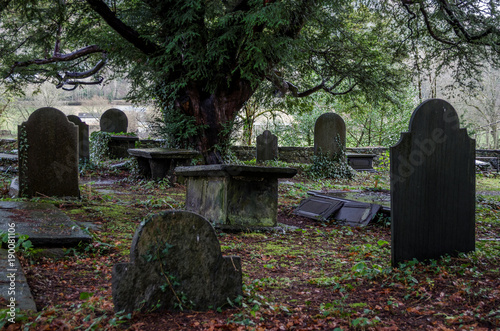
[128,147,200,182]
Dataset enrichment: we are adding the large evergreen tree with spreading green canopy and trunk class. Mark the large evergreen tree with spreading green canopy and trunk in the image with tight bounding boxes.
[0,0,500,163]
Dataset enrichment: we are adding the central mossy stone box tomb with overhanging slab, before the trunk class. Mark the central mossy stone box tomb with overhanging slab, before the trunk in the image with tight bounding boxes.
[175,164,297,231]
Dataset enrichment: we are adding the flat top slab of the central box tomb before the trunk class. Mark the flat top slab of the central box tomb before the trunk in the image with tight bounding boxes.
[175,164,297,178]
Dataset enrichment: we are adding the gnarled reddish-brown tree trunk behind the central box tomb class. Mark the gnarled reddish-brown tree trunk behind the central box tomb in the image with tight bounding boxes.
[175,79,255,164]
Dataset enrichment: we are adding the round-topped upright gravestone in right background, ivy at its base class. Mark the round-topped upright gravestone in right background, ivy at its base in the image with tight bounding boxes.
[314,113,346,159]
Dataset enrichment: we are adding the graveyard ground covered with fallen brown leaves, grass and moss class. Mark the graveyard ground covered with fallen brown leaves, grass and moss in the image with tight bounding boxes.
[0,155,500,330]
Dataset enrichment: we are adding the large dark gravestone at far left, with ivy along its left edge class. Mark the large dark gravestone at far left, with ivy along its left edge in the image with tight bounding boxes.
[18,108,80,197]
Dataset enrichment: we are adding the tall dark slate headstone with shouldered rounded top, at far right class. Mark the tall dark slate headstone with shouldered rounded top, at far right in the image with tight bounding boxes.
[391,99,475,266]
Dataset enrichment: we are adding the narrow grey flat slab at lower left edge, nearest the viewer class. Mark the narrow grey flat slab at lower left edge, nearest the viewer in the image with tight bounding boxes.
[0,249,36,312]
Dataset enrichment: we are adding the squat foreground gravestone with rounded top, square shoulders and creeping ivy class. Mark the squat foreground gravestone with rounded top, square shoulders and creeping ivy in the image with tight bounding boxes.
[112,211,242,312]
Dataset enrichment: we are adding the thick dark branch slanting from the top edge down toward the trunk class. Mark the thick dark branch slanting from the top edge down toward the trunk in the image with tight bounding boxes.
[86,0,160,55]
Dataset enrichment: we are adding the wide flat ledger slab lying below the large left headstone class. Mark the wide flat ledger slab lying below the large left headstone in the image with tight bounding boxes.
[0,201,92,247]
